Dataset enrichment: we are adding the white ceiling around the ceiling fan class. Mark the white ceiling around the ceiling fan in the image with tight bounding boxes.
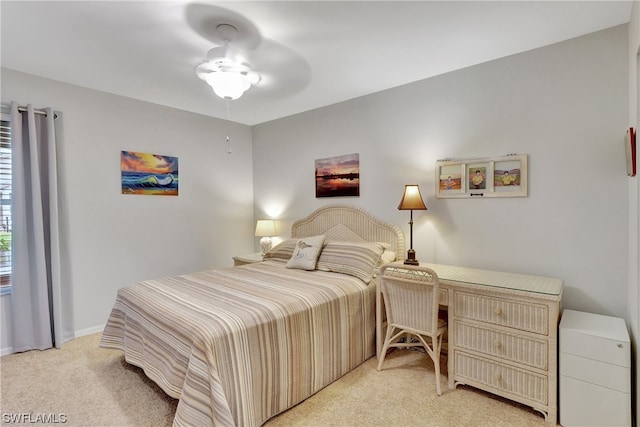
[0,0,632,125]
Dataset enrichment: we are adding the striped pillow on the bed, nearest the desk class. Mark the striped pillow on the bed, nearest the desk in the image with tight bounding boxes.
[317,241,384,283]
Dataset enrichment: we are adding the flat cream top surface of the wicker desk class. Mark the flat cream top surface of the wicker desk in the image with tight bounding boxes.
[412,263,563,295]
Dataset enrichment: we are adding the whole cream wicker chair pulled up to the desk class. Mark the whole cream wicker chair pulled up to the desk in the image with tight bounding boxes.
[378,264,447,396]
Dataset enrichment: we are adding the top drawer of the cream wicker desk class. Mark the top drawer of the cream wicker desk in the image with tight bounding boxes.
[453,291,549,335]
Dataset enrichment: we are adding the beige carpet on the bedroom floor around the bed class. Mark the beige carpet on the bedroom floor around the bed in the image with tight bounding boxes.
[0,334,546,427]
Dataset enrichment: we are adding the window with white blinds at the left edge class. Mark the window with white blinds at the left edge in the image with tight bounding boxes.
[0,114,12,295]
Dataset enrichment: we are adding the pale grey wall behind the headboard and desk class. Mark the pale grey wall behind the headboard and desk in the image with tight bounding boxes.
[253,26,629,318]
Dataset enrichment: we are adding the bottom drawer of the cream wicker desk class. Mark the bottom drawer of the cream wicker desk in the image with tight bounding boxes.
[454,350,555,405]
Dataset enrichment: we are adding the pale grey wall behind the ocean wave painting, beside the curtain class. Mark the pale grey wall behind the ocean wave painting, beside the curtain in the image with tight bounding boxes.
[0,69,255,353]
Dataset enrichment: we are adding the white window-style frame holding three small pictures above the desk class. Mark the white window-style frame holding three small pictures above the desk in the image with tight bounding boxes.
[436,154,527,198]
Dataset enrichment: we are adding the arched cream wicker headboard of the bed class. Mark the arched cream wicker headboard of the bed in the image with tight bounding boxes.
[291,205,404,259]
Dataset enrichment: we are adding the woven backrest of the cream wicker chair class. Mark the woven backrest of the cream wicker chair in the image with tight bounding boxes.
[378,264,440,336]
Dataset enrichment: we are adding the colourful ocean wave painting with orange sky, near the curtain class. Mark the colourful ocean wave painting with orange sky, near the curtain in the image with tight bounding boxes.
[120,151,179,196]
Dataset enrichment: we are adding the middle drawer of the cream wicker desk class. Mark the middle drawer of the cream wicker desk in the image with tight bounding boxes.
[453,320,549,371]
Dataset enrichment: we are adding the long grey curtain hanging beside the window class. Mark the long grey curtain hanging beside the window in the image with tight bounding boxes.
[11,102,73,352]
